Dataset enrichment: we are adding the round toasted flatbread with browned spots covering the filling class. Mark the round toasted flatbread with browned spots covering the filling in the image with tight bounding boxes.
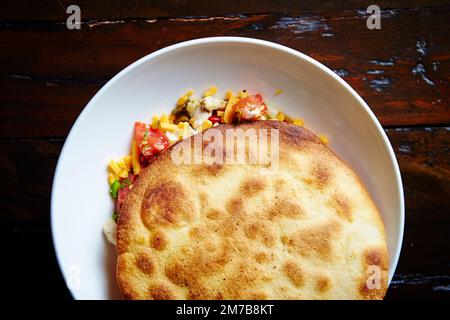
[117,121,388,299]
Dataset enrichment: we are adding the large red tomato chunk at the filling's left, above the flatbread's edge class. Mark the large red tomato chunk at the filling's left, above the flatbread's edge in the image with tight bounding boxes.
[134,122,169,157]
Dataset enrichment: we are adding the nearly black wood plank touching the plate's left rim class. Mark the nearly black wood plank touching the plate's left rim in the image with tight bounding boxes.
[0,139,64,228]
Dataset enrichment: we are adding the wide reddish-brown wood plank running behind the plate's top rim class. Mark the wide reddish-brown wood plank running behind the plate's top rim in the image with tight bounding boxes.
[0,9,450,138]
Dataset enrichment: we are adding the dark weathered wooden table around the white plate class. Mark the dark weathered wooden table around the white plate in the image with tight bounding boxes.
[0,0,450,299]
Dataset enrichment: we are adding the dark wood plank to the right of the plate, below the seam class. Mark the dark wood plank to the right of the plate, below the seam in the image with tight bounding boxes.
[387,128,450,299]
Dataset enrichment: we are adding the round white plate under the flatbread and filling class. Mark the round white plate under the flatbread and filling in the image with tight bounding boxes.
[51,37,404,299]
